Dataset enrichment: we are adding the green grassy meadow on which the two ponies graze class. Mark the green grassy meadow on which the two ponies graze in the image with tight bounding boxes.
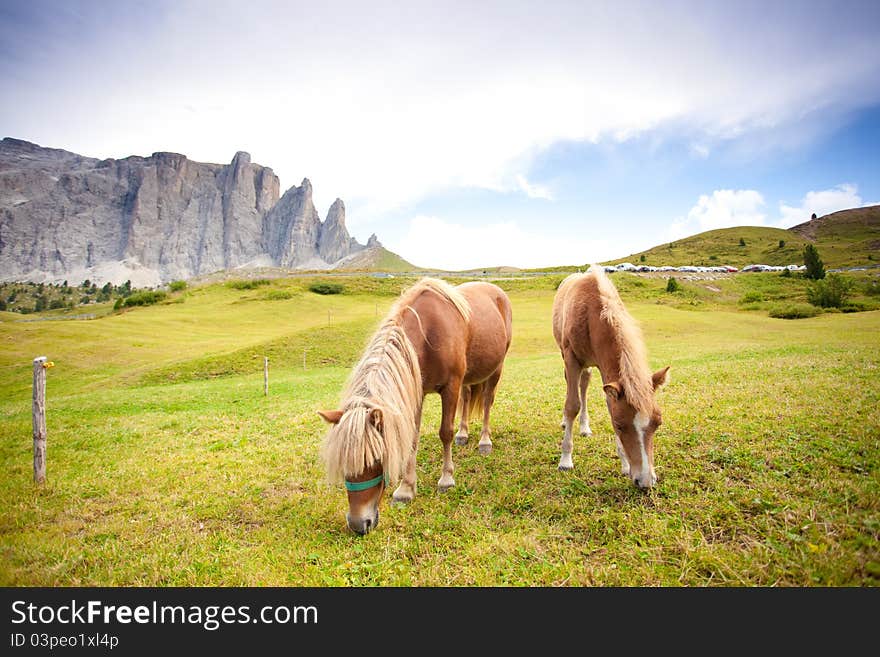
[0,273,880,587]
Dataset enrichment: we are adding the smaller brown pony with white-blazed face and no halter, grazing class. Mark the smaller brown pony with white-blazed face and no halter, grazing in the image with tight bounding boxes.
[553,265,669,488]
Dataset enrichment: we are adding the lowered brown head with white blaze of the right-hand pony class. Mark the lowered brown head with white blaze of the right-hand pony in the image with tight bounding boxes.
[603,367,669,488]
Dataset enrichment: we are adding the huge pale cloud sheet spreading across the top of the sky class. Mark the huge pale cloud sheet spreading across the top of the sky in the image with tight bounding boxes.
[0,0,880,223]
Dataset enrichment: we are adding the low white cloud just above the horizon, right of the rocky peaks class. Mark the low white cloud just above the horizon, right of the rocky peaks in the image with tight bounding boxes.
[387,215,608,270]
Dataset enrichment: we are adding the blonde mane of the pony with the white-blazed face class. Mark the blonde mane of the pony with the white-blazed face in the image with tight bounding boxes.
[587,265,654,415]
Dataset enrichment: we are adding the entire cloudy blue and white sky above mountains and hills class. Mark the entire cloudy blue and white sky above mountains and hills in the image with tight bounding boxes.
[0,0,880,270]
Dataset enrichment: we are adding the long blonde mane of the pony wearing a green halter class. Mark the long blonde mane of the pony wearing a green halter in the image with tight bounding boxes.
[322,278,470,482]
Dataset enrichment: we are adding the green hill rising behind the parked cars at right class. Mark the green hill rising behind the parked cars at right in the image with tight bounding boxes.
[605,205,880,267]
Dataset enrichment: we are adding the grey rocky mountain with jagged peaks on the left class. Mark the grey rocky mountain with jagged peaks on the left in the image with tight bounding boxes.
[0,137,378,287]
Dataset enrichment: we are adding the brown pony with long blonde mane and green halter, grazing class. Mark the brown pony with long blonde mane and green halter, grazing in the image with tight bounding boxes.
[318,278,511,534]
